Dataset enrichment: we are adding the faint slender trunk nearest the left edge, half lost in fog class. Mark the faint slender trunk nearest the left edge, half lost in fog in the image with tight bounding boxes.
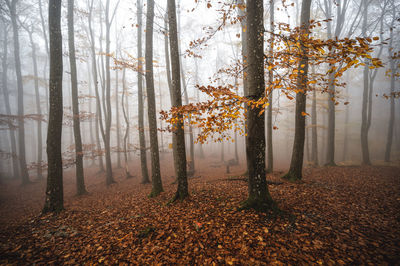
[2,26,19,178]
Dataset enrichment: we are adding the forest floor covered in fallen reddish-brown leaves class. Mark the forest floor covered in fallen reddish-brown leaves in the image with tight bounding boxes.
[0,154,400,265]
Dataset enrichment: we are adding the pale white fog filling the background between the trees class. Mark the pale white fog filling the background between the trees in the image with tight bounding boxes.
[0,0,400,180]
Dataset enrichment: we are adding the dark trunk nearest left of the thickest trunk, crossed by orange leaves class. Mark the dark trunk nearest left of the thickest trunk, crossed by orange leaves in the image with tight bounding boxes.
[168,0,188,201]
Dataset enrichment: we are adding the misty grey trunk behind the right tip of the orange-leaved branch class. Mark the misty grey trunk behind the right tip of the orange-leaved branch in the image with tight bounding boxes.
[361,1,372,165]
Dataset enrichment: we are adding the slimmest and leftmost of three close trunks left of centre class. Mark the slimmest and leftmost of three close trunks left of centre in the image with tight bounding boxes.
[137,0,150,184]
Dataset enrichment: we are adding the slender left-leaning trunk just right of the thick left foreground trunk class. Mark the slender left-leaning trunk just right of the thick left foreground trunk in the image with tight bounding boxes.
[68,0,86,195]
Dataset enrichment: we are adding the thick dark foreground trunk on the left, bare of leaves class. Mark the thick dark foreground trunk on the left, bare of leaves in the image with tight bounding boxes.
[43,0,64,213]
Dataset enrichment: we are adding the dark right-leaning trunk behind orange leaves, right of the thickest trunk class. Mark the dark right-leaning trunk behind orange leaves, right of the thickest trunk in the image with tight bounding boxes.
[284,0,311,181]
